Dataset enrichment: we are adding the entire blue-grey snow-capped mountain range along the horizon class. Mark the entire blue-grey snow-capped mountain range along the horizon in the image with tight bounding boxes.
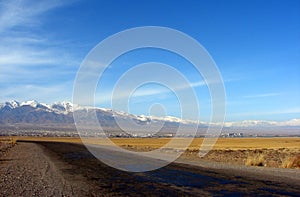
[0,100,300,129]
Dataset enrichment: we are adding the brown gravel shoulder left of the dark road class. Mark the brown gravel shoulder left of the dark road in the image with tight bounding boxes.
[0,143,94,196]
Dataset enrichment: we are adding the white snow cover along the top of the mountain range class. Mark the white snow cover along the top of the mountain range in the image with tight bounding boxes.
[0,100,300,128]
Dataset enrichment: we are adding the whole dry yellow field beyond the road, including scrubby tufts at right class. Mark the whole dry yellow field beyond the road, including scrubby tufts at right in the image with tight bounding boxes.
[17,137,300,168]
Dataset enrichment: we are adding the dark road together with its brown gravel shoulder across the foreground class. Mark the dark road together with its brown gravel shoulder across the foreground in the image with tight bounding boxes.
[0,142,300,196]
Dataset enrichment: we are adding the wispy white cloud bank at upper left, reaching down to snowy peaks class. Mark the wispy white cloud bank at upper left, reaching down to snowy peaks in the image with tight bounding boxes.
[0,0,80,101]
